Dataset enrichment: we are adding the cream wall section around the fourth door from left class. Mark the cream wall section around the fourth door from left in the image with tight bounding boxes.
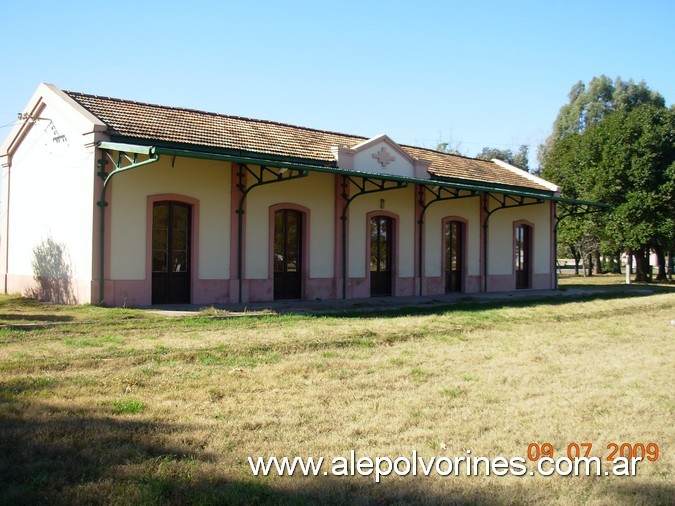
[424,197,481,277]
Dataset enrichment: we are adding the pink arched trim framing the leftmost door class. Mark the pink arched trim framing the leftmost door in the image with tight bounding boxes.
[146,193,199,303]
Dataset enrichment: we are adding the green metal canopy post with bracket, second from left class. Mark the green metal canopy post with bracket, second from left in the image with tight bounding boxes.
[237,163,309,302]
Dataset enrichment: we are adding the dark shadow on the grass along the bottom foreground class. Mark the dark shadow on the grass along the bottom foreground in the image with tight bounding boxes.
[0,396,675,506]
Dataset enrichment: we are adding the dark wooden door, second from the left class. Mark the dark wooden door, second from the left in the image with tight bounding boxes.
[273,209,302,299]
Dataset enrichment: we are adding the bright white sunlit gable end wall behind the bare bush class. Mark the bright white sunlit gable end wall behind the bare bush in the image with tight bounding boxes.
[3,102,96,292]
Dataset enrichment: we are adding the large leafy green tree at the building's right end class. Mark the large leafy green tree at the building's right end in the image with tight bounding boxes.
[543,99,675,280]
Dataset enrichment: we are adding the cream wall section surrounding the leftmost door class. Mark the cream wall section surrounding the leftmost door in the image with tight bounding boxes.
[108,156,231,280]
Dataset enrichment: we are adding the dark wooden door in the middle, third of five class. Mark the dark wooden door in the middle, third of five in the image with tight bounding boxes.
[370,216,394,297]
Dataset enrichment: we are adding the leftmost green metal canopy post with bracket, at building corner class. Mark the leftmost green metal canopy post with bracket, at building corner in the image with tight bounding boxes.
[96,142,159,305]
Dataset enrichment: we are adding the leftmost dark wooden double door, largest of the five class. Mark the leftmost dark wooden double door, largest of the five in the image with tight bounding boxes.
[152,202,192,304]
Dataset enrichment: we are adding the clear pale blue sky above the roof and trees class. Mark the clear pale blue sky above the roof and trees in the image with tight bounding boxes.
[0,0,675,167]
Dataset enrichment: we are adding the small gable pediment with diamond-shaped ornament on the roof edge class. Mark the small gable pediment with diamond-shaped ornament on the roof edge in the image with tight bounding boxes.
[332,135,431,179]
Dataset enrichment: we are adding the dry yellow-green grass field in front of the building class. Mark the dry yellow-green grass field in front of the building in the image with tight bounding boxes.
[0,277,675,505]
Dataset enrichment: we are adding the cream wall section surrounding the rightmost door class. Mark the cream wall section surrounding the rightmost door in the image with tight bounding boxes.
[488,202,551,275]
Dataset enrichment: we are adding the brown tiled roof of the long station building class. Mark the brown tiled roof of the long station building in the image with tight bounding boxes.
[65,91,550,191]
